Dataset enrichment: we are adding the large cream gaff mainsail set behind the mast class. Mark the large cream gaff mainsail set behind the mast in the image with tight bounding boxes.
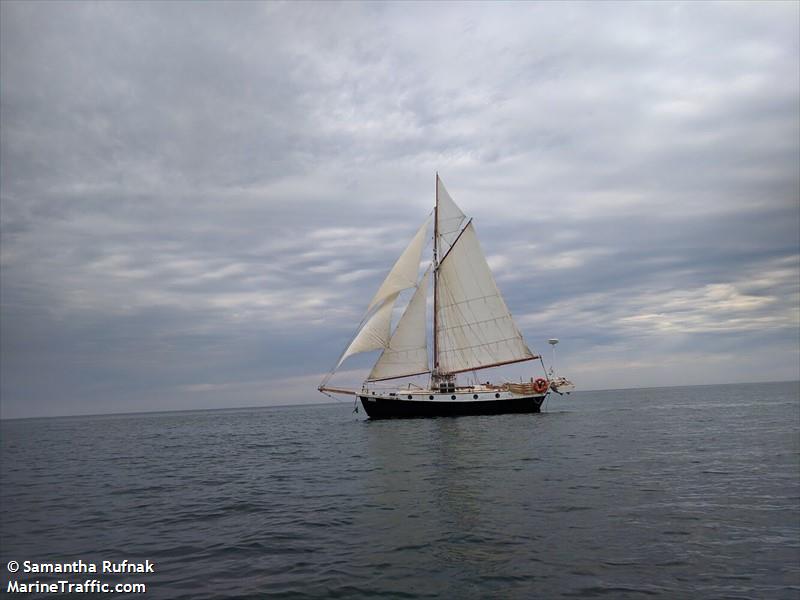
[437,223,535,373]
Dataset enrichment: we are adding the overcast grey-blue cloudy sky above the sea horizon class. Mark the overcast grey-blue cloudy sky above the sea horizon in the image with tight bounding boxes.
[0,2,800,417]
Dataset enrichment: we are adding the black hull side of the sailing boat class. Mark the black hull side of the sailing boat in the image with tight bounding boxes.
[359,396,545,419]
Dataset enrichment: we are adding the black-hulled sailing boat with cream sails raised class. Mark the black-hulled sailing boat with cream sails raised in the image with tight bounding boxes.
[318,173,574,419]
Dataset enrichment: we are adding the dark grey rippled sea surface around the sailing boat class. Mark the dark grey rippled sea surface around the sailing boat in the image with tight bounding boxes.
[0,383,800,600]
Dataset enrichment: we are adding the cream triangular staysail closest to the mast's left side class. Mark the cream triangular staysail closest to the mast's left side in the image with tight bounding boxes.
[367,269,430,380]
